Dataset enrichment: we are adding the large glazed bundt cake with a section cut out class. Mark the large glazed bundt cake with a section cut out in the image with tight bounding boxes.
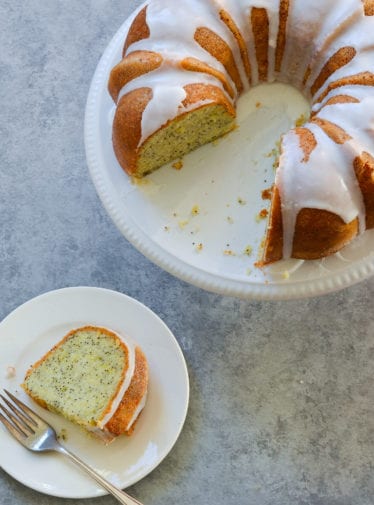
[108,0,374,266]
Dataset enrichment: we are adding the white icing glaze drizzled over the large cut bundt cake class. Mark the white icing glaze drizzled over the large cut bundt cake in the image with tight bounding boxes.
[114,0,374,258]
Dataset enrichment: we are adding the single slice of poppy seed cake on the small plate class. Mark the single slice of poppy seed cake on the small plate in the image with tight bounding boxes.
[22,326,148,440]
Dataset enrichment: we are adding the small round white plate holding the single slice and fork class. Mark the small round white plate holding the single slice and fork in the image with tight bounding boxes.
[0,287,189,498]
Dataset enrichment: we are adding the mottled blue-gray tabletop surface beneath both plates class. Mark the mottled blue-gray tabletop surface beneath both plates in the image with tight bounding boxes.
[0,0,374,505]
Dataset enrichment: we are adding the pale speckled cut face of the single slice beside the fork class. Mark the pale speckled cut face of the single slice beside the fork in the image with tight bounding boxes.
[25,330,127,426]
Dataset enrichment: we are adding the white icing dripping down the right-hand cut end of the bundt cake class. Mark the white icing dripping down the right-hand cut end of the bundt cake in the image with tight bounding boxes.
[276,124,365,259]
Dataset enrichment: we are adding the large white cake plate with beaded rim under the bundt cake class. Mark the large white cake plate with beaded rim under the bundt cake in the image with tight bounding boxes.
[85,7,374,299]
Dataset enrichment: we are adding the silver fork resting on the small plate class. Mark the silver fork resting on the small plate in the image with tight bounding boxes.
[0,389,142,505]
